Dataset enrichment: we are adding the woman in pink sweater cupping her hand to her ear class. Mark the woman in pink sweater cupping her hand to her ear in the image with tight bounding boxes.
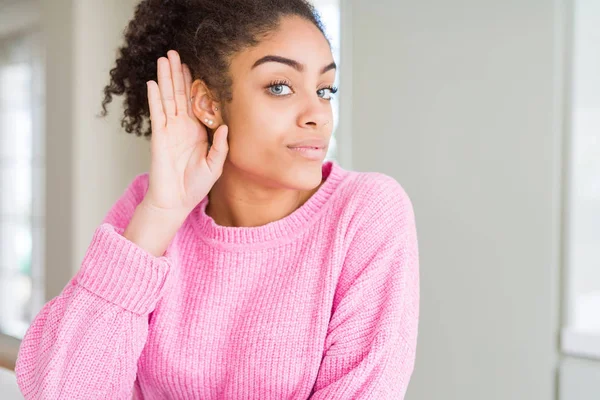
[16,0,419,400]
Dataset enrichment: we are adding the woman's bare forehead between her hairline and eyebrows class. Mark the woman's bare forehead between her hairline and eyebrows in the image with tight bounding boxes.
[231,16,333,73]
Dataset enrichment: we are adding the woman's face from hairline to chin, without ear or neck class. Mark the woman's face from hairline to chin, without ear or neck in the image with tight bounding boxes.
[213,17,336,190]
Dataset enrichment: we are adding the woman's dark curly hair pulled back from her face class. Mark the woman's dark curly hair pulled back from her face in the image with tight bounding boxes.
[100,0,331,141]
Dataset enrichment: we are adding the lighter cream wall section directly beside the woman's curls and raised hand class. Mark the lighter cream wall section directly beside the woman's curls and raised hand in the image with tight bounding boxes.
[73,0,152,276]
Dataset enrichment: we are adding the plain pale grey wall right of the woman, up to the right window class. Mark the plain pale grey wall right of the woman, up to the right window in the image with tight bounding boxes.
[340,0,563,400]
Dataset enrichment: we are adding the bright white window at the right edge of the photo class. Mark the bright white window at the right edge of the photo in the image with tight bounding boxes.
[562,0,600,358]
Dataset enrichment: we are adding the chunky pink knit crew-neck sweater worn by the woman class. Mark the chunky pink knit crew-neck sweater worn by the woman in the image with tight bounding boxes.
[16,161,419,400]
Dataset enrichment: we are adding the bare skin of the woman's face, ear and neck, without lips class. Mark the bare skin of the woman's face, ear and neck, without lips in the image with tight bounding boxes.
[190,17,336,227]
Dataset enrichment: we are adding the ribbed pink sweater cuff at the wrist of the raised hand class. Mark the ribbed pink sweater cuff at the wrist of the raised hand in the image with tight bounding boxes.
[77,223,170,314]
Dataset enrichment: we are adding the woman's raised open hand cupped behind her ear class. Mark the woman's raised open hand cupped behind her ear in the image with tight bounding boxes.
[143,50,229,217]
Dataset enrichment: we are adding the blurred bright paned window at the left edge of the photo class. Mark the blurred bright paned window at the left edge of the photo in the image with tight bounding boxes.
[0,31,44,339]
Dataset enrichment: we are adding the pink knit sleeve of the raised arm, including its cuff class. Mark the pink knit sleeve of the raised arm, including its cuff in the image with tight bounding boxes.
[15,174,172,400]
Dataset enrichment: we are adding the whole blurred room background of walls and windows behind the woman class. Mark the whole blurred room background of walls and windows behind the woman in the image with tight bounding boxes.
[0,0,600,400]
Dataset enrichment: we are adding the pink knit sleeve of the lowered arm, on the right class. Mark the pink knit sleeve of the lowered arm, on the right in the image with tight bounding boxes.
[309,176,419,400]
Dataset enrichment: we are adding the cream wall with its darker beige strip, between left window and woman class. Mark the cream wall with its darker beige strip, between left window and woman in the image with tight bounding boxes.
[40,0,150,299]
